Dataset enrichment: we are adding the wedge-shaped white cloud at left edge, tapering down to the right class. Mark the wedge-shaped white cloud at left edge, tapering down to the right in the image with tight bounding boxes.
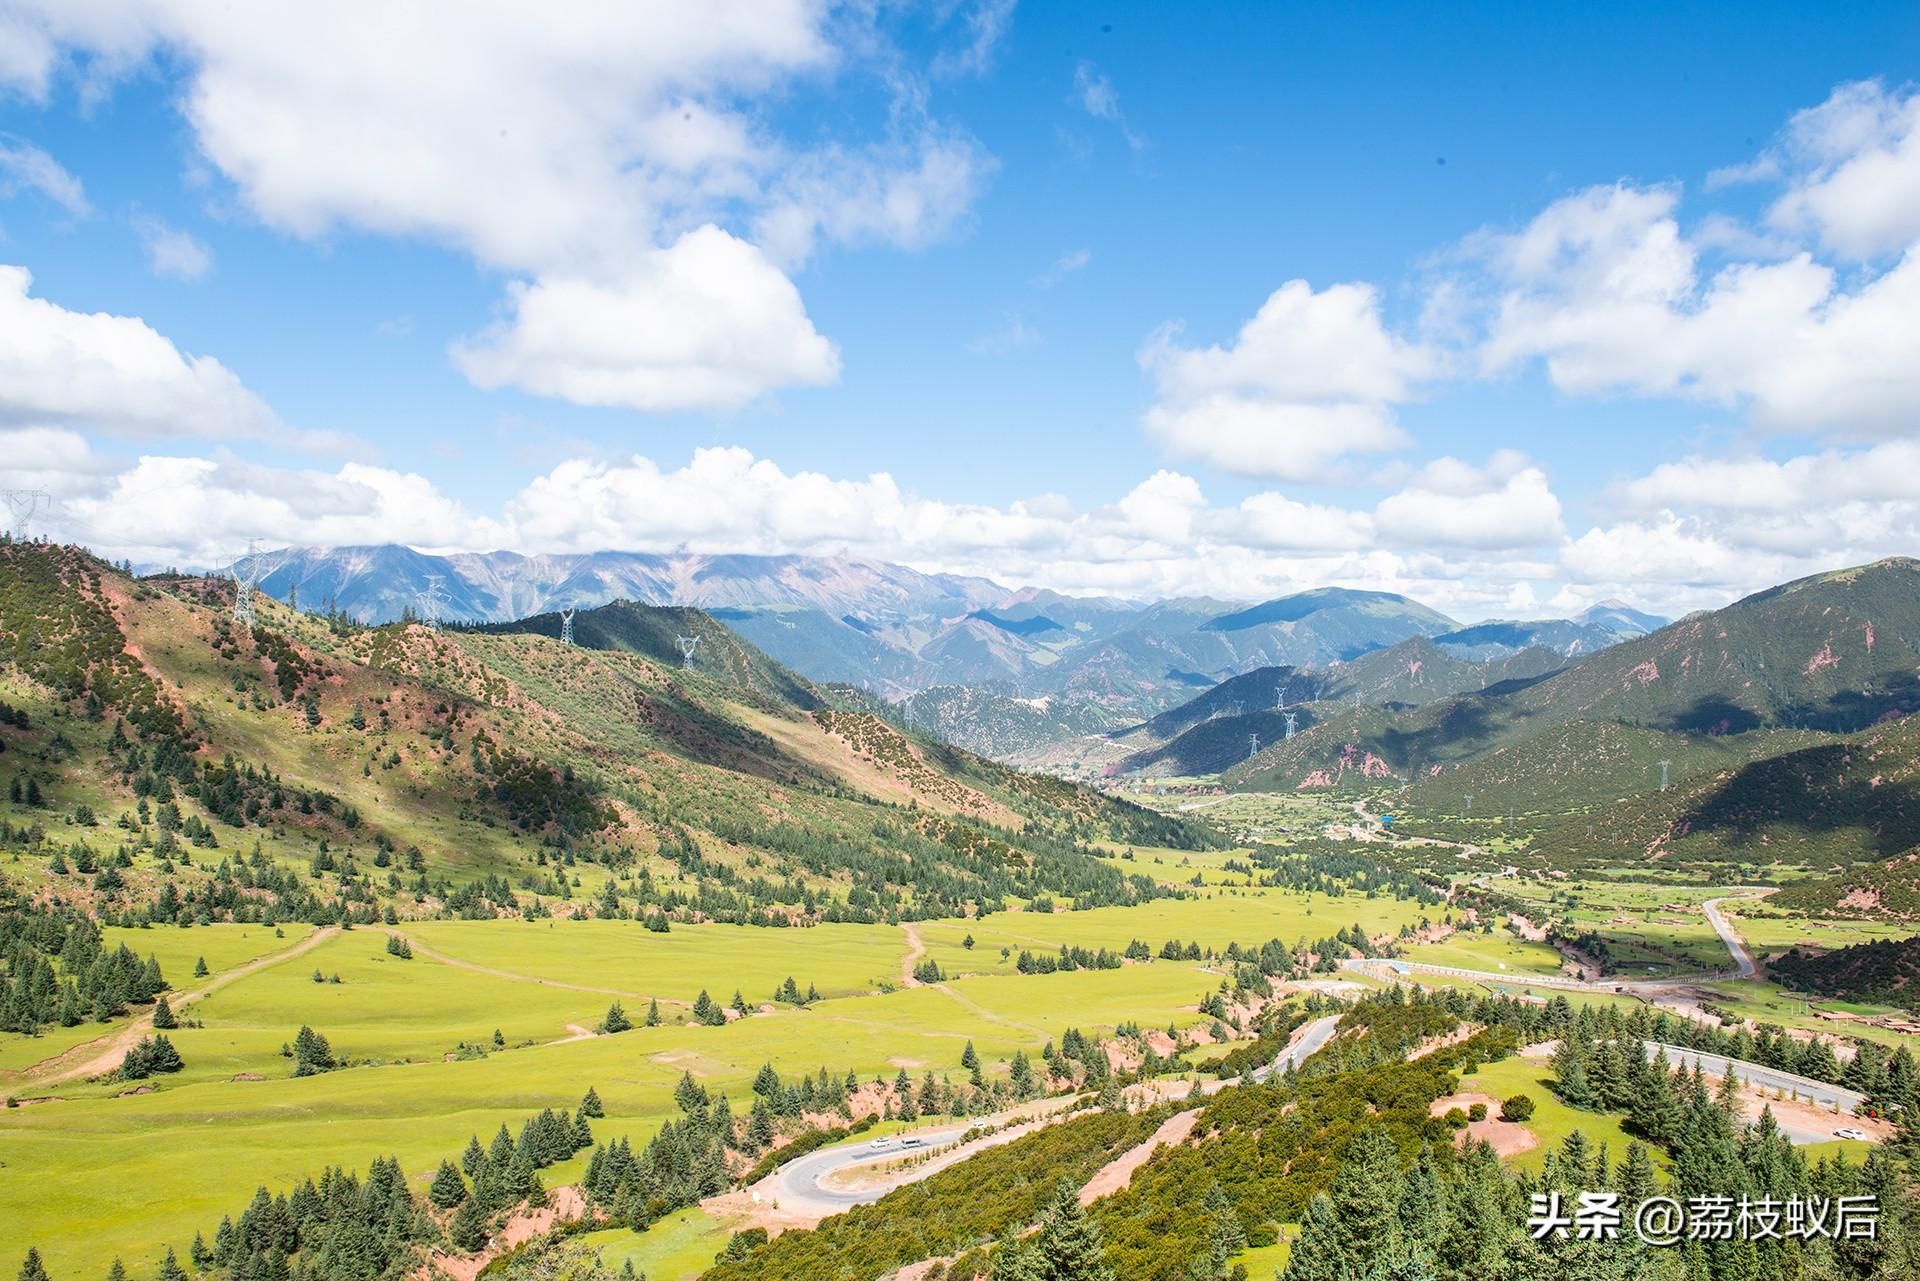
[0,267,293,444]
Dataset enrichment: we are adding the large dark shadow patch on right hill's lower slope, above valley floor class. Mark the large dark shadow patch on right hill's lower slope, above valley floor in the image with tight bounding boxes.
[1680,743,1920,857]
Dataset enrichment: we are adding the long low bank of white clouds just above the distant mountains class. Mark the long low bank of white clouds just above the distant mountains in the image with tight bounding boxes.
[15,428,1553,616]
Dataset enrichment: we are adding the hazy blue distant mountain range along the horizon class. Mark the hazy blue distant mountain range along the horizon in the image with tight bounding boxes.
[236,545,1663,722]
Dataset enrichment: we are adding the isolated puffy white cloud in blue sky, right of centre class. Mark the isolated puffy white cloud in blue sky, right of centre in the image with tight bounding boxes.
[1139,280,1436,480]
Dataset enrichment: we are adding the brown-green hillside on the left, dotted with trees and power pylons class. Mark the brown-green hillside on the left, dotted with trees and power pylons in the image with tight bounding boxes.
[0,545,1210,922]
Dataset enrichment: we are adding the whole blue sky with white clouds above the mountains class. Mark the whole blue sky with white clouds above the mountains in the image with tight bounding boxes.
[0,0,1920,616]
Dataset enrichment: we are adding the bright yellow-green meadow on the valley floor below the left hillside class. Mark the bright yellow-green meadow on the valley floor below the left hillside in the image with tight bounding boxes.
[0,918,1215,1277]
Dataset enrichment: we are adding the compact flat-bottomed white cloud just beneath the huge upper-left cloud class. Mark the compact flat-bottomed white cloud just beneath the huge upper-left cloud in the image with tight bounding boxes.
[455,227,839,409]
